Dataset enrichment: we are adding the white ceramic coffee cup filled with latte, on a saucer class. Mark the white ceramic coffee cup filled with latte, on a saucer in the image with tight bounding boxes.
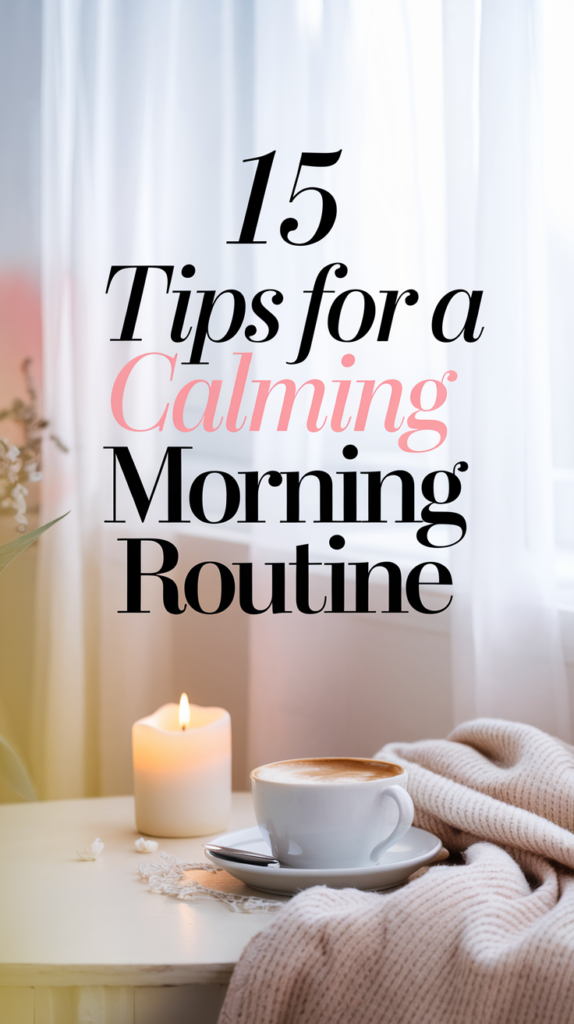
[250,758,414,868]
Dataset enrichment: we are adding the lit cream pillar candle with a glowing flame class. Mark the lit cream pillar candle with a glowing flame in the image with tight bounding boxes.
[132,693,231,837]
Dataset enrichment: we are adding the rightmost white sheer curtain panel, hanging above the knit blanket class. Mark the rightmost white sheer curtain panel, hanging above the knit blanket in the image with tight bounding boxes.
[444,0,571,739]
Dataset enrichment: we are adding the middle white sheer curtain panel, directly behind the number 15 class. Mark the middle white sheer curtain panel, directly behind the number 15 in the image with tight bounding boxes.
[251,2,454,764]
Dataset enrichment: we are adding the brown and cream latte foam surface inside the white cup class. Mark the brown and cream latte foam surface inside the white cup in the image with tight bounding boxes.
[253,758,403,784]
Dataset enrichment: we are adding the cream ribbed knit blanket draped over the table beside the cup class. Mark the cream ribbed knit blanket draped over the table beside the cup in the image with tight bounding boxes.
[219,719,574,1024]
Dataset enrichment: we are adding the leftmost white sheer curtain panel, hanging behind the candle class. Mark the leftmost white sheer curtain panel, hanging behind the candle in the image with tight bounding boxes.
[33,0,246,797]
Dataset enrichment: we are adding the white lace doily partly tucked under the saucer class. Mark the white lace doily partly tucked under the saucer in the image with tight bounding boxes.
[139,853,289,913]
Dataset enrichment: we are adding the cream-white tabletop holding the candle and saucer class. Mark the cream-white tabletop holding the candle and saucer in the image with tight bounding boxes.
[0,793,278,986]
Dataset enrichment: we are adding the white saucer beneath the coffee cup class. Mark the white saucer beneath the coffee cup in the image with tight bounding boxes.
[206,826,442,896]
